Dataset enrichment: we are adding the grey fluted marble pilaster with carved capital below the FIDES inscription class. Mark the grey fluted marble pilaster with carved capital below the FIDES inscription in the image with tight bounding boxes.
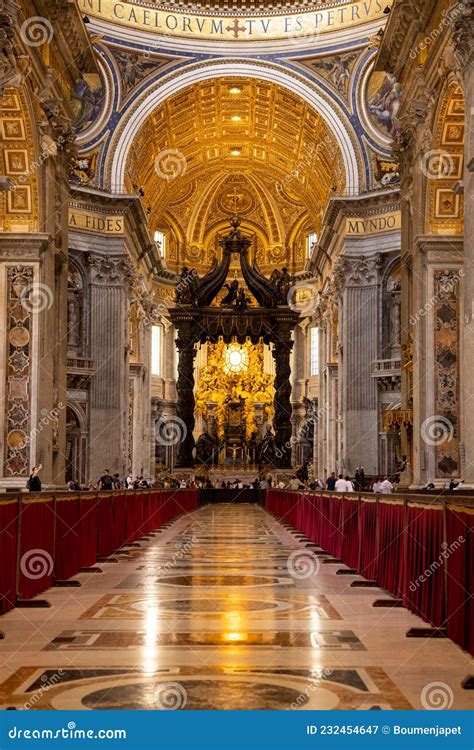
[90,255,131,481]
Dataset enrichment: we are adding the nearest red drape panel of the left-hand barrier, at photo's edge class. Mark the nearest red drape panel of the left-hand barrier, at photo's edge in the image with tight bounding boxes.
[0,499,18,614]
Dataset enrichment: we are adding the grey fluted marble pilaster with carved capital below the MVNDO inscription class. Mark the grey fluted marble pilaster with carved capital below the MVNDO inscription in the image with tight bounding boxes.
[340,256,379,475]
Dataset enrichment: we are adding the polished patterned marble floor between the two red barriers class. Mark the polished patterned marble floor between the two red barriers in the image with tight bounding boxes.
[0,505,473,710]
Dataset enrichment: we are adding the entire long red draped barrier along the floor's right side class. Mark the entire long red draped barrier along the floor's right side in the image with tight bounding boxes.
[266,490,474,653]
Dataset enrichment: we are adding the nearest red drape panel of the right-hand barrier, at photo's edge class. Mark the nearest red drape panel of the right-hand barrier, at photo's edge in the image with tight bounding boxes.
[446,507,474,654]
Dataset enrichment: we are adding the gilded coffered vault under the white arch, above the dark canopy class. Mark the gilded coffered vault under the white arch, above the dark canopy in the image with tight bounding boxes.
[126,78,344,270]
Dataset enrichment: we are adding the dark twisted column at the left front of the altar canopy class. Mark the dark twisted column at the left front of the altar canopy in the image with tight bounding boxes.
[175,321,196,469]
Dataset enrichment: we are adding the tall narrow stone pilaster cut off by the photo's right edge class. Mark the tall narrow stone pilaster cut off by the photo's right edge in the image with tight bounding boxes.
[452,0,474,486]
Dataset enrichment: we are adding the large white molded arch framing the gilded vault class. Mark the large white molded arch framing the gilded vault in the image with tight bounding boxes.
[107,60,361,195]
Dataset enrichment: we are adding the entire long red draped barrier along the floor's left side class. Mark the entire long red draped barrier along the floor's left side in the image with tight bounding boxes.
[0,490,198,615]
